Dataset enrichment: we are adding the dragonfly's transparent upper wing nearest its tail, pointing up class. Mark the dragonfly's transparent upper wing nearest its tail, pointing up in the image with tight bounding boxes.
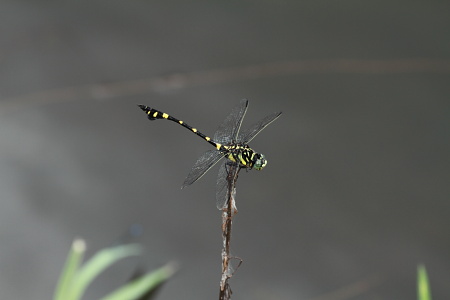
[213,99,248,144]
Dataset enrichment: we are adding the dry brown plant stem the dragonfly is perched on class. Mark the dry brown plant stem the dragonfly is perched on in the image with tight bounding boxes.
[219,165,240,300]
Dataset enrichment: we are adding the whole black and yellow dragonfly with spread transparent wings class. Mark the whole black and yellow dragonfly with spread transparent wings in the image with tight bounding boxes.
[138,99,281,210]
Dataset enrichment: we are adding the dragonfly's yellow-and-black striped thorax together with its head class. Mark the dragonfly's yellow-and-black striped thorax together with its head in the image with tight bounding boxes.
[223,144,267,170]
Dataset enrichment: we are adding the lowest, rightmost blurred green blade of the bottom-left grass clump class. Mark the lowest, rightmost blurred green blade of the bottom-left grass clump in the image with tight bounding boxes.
[101,263,176,300]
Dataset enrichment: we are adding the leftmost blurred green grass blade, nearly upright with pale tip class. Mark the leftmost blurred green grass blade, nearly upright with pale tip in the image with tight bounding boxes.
[53,239,86,300]
